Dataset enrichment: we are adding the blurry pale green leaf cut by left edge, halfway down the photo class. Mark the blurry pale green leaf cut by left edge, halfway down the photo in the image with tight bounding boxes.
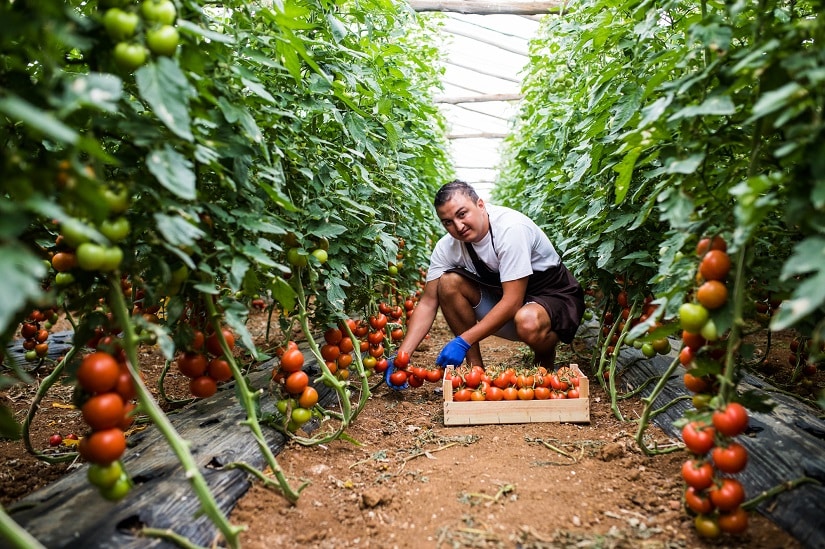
[0,242,46,334]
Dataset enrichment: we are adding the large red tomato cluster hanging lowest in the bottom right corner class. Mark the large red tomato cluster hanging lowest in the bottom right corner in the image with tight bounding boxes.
[682,402,748,538]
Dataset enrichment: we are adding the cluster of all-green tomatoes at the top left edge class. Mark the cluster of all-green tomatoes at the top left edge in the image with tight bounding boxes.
[99,0,180,72]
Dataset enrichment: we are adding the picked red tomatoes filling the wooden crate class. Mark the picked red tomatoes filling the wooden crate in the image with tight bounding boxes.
[445,366,580,402]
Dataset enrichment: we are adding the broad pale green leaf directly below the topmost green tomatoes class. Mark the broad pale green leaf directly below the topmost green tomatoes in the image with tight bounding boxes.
[135,57,194,141]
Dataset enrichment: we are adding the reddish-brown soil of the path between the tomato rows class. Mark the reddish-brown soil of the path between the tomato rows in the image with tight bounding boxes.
[0,306,822,549]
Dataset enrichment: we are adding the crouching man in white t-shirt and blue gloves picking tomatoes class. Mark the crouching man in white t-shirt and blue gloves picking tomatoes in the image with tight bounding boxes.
[386,180,584,388]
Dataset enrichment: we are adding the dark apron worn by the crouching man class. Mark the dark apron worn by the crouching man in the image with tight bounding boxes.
[447,218,584,343]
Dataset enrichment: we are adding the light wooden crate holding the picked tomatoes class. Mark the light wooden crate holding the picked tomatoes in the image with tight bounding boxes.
[443,364,590,425]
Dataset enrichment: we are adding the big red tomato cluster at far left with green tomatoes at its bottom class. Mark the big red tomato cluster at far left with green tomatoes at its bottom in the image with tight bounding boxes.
[75,346,136,500]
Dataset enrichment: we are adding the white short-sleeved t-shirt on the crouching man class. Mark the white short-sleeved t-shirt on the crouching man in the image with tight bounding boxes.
[427,204,561,282]
